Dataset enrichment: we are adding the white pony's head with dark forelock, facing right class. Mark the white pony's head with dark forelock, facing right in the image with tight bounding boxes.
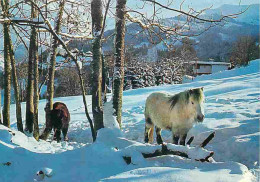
[187,87,205,122]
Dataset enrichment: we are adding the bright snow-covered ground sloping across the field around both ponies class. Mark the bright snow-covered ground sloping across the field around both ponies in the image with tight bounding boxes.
[0,60,260,182]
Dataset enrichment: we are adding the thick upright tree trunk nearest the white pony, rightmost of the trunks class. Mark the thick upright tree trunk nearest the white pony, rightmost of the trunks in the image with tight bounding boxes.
[113,0,126,127]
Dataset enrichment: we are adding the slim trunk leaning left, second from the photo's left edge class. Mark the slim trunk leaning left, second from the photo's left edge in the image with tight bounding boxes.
[7,30,23,132]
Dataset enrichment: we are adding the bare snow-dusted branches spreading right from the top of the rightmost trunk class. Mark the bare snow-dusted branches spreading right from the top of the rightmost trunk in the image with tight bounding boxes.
[126,0,248,50]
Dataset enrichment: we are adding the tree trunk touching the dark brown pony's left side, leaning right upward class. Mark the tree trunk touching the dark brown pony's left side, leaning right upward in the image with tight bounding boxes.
[40,0,65,140]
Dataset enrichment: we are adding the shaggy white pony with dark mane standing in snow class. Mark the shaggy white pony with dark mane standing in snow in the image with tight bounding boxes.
[144,87,204,145]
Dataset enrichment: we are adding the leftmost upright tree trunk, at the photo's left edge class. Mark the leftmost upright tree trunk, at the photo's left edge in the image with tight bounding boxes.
[1,0,11,128]
